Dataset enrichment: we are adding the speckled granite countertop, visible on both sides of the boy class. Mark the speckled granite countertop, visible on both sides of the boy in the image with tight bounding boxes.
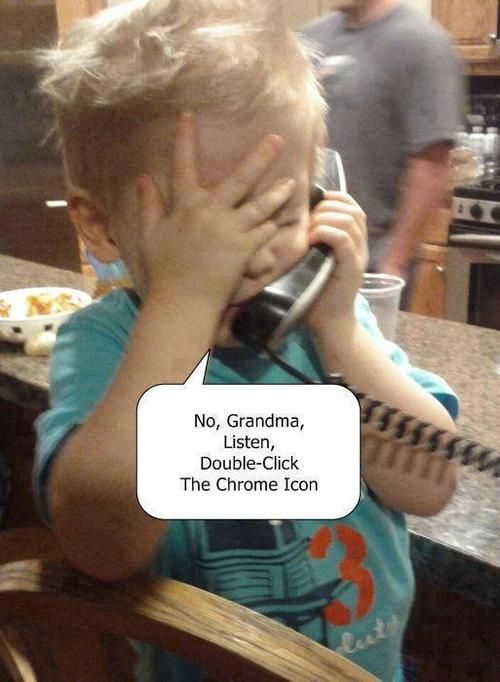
[0,256,500,607]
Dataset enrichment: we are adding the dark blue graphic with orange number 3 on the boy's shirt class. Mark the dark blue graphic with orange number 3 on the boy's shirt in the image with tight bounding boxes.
[197,520,374,645]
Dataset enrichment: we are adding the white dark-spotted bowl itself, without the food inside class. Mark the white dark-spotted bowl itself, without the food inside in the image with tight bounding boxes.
[0,287,92,343]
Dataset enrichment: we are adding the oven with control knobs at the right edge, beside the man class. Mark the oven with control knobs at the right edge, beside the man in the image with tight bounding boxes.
[446,176,500,330]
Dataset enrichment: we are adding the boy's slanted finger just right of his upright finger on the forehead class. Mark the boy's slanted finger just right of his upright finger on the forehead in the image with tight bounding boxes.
[220,135,283,208]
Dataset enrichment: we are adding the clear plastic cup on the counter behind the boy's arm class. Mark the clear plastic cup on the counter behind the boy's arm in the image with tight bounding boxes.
[359,273,406,341]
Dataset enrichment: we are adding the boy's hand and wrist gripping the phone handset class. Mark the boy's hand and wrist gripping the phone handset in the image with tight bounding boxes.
[306,192,368,334]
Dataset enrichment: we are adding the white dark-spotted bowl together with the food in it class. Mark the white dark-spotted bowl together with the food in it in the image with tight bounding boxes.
[0,287,92,343]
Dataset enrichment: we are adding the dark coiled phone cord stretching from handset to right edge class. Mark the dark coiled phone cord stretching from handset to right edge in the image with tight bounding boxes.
[258,347,500,477]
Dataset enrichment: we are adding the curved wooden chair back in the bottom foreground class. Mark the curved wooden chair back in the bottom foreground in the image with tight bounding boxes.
[0,529,375,682]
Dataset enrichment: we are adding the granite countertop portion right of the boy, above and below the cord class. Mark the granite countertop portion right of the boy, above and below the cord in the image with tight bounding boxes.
[397,313,500,607]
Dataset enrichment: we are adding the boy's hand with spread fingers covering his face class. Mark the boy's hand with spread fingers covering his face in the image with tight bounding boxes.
[138,114,295,307]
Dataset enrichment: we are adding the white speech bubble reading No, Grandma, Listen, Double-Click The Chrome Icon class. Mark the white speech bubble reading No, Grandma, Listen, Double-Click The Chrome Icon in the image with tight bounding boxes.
[137,353,360,520]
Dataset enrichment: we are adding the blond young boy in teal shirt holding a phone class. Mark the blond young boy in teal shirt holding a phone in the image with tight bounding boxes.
[35,0,456,681]
